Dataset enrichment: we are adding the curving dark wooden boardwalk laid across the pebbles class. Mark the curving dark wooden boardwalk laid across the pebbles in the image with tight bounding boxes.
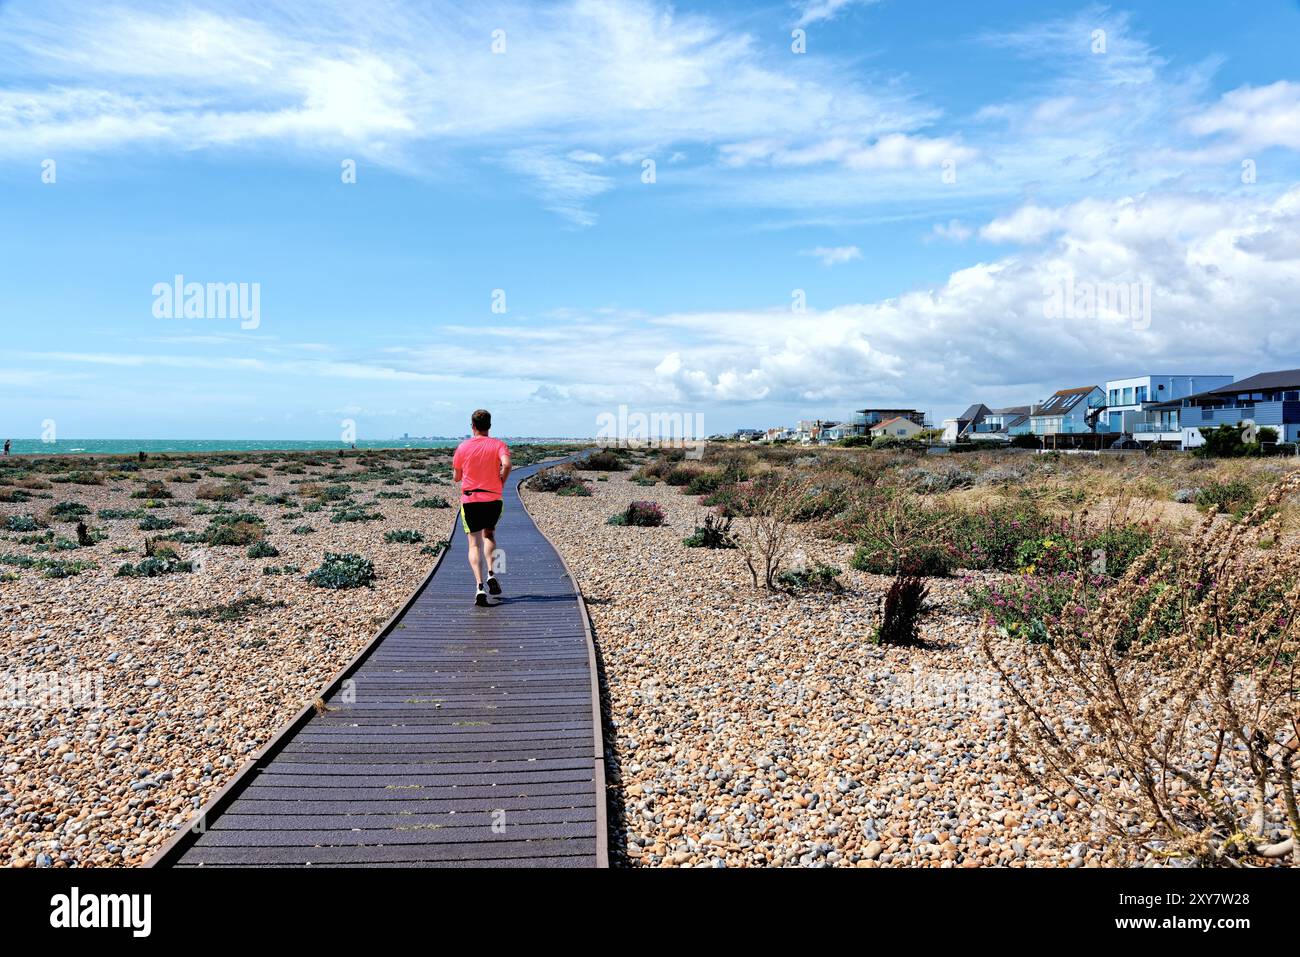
[150,455,608,867]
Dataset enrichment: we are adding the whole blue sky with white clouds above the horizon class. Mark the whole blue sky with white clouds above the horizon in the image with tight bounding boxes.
[0,0,1300,438]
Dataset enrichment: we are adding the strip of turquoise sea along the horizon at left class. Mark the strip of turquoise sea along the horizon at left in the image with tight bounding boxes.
[0,436,579,455]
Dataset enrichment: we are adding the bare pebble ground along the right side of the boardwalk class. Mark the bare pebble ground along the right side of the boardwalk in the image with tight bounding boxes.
[524,462,1110,867]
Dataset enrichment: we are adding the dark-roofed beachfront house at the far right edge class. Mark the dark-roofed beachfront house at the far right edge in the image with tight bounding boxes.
[1134,369,1300,449]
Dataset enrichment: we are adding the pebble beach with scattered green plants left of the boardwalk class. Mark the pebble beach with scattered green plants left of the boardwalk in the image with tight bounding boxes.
[0,450,496,867]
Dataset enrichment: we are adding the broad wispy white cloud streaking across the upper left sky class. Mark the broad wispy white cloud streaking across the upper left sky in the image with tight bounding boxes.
[0,0,933,224]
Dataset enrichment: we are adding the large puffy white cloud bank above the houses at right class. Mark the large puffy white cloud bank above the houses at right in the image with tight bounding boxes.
[655,187,1300,410]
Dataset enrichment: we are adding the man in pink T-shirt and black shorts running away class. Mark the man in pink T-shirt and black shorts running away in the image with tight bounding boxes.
[451,408,510,606]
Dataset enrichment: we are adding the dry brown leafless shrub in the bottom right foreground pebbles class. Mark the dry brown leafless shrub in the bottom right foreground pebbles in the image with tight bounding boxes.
[980,473,1300,866]
